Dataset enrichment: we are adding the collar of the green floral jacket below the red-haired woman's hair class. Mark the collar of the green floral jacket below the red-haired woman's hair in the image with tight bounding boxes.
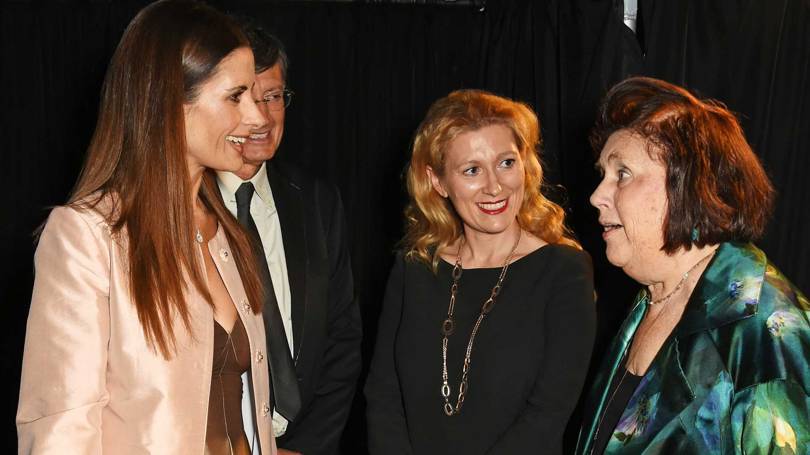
[675,243,767,338]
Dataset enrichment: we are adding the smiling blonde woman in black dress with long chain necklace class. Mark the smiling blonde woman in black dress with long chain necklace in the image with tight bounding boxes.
[366,90,595,455]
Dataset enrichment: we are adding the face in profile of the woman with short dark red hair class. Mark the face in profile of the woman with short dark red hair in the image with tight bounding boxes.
[590,130,668,284]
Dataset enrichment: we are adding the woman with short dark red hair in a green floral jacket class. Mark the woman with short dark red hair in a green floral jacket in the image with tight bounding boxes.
[577,78,810,454]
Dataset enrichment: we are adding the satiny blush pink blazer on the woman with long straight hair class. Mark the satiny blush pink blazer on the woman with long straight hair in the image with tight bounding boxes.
[16,203,276,455]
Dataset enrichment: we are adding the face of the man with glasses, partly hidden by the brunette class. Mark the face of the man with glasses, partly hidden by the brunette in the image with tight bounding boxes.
[236,63,284,180]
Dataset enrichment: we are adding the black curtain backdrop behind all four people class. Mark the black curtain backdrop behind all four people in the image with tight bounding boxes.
[0,0,810,453]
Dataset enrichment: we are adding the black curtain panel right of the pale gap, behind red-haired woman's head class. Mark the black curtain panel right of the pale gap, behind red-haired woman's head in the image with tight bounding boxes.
[640,0,810,292]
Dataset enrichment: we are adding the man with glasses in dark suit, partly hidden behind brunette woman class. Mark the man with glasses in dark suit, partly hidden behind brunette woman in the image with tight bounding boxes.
[218,23,362,455]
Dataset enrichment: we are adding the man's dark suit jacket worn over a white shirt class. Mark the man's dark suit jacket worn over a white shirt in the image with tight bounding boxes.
[267,159,362,455]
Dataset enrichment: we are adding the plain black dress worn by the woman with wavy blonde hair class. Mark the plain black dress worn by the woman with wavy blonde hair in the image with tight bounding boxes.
[365,245,596,455]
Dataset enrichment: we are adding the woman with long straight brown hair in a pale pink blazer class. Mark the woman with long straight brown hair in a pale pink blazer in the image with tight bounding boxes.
[17,1,275,455]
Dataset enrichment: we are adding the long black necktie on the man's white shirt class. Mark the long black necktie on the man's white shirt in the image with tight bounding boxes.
[236,182,301,422]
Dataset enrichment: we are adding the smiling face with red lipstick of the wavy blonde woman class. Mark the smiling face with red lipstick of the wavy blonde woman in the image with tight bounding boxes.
[427,125,525,239]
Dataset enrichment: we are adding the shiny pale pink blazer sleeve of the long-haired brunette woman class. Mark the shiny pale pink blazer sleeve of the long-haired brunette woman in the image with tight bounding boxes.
[16,207,111,454]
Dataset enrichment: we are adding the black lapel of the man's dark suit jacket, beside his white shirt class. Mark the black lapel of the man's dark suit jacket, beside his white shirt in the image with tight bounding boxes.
[267,161,309,364]
